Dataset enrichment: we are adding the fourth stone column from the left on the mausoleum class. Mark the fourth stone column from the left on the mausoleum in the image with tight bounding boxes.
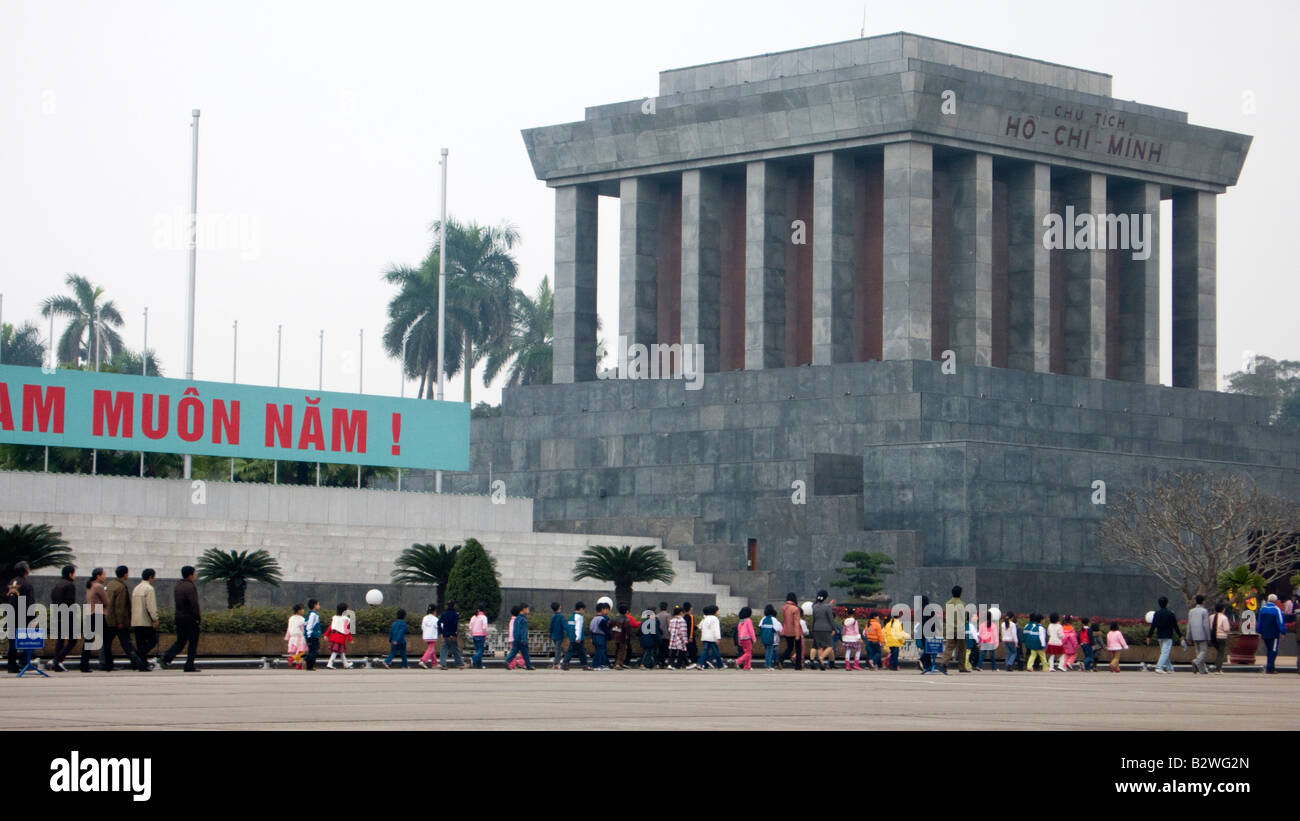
[745,161,789,370]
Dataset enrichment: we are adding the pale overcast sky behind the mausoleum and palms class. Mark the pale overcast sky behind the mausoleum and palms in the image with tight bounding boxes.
[0,0,1300,401]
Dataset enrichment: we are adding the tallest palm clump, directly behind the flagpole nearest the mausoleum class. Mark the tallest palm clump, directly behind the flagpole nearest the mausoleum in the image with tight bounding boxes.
[384,220,519,404]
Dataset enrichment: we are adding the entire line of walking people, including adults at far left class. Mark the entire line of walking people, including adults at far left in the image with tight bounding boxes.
[8,562,1287,674]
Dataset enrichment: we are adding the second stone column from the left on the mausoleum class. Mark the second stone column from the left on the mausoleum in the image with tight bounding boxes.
[619,177,659,346]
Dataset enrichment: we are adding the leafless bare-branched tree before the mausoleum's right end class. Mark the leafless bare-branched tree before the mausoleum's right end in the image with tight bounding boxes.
[1099,473,1300,603]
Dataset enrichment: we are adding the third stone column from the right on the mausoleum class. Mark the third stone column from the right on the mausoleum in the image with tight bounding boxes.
[1061,174,1106,379]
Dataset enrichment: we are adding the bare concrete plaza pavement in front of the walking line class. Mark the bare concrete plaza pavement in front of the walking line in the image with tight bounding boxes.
[0,669,1300,730]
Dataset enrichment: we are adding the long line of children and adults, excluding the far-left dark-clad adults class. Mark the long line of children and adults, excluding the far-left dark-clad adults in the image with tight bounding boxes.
[299,587,1286,674]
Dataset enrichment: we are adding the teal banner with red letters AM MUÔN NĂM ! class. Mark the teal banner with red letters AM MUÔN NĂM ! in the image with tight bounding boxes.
[0,365,469,470]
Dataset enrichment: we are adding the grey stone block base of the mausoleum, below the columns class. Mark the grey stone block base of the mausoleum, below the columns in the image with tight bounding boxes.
[439,361,1300,616]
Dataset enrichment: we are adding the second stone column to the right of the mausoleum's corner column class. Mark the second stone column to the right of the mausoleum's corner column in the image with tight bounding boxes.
[1006,162,1052,373]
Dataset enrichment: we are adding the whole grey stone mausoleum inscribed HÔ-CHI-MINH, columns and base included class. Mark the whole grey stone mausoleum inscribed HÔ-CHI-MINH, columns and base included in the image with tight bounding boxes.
[413,34,1284,616]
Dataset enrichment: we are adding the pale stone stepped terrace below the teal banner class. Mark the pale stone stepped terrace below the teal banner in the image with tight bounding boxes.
[0,473,746,614]
